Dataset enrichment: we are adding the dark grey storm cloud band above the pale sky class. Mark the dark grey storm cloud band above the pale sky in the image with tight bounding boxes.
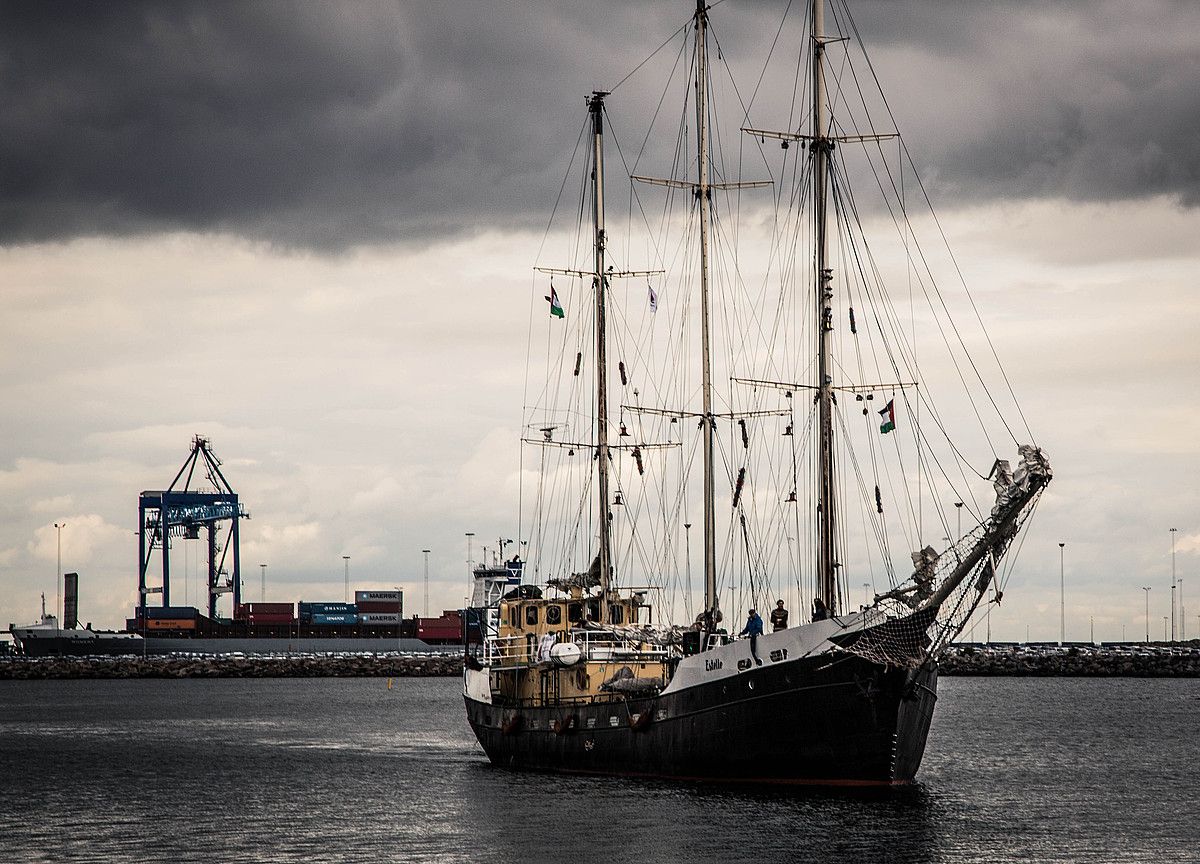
[0,0,1200,250]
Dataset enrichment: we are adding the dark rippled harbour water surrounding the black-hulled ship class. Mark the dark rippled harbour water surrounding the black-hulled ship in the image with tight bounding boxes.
[0,678,1200,864]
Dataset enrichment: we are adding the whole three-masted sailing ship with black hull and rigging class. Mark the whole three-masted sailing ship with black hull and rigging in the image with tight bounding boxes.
[463,0,1051,785]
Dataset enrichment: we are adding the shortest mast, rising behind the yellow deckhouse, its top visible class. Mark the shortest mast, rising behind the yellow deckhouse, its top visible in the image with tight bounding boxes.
[588,90,612,624]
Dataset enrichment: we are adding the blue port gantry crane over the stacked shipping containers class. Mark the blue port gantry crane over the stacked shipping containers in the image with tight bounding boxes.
[138,436,250,620]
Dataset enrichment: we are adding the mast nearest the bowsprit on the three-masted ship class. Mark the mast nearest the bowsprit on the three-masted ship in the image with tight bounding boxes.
[812,0,839,614]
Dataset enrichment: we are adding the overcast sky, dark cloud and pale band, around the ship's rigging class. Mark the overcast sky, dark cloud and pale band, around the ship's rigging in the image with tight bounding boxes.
[0,0,1200,638]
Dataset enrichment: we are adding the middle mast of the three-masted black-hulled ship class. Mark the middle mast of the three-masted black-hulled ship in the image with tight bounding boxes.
[696,0,716,611]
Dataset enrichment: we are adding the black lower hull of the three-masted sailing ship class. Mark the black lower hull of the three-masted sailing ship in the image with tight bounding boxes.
[467,654,937,786]
